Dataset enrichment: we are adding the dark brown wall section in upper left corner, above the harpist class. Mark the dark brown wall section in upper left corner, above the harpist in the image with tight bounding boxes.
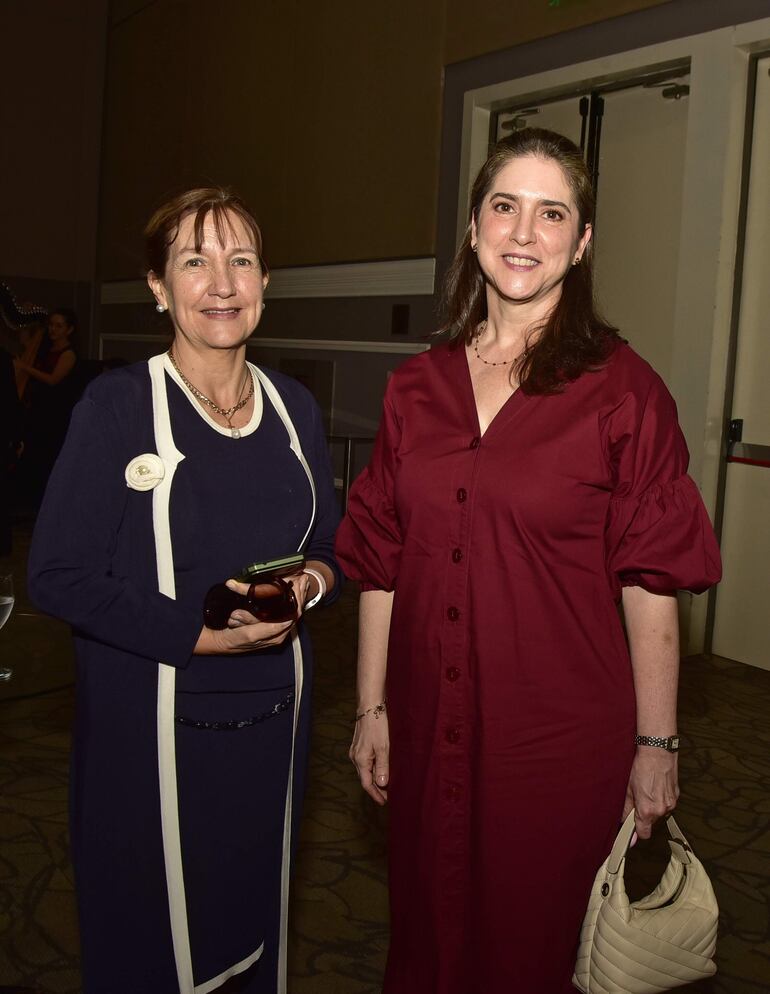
[0,0,107,284]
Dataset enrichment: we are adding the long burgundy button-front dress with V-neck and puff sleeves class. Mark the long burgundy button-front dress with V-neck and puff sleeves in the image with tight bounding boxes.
[337,345,720,994]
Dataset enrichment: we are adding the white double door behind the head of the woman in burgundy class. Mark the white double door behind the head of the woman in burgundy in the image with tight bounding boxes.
[497,75,689,381]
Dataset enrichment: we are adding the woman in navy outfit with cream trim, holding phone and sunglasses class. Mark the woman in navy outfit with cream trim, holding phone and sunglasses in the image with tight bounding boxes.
[30,189,338,994]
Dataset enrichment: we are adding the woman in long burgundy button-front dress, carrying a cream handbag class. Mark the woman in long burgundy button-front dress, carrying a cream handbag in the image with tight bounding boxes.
[337,129,720,994]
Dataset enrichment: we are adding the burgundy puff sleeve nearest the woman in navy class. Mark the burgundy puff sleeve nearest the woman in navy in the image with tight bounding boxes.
[336,380,402,590]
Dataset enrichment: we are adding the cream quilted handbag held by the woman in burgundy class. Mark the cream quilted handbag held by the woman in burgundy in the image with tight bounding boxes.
[572,811,719,994]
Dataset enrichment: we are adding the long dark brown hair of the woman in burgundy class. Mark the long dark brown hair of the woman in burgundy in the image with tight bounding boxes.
[441,128,621,394]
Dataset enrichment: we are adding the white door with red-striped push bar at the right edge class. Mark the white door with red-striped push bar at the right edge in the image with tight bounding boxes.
[713,57,770,669]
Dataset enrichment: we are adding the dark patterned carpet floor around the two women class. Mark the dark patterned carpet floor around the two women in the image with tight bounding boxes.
[0,524,770,994]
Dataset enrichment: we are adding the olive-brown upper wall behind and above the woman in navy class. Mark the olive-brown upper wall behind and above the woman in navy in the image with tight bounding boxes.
[101,0,662,280]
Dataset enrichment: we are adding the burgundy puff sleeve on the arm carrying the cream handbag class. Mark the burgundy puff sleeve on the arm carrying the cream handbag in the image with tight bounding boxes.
[606,376,721,597]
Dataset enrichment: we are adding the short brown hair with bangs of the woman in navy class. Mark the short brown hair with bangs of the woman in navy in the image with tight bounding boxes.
[144,186,269,276]
